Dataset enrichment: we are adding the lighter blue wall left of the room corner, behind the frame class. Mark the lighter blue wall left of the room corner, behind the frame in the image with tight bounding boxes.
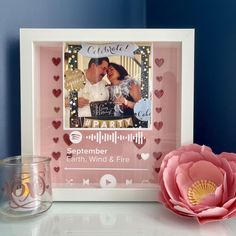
[0,0,145,158]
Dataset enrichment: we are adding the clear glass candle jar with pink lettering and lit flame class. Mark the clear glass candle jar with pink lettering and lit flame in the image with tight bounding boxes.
[0,156,52,217]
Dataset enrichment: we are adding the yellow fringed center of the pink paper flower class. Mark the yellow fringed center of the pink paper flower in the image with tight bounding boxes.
[188,180,217,205]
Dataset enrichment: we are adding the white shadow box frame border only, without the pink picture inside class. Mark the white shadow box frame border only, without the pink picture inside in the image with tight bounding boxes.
[20,29,194,202]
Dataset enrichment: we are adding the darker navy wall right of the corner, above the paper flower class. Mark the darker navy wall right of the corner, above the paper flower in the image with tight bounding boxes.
[146,0,236,152]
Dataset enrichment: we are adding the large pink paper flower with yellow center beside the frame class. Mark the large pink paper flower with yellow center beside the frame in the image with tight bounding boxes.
[159,144,236,223]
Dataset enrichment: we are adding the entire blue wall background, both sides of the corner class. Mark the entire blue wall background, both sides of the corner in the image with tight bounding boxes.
[0,0,236,157]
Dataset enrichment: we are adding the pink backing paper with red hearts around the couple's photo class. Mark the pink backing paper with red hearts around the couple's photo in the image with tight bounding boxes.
[38,43,181,188]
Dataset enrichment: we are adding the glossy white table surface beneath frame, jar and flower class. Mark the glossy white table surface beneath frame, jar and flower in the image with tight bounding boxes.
[0,202,236,236]
